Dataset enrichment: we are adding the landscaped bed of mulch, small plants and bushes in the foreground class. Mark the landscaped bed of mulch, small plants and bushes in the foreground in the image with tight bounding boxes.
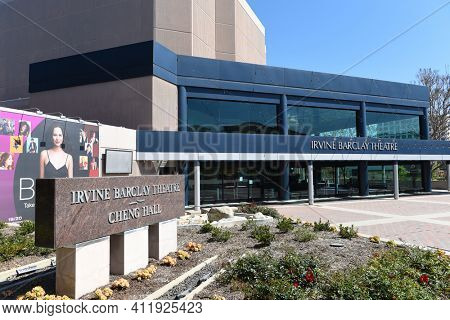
[2,208,450,300]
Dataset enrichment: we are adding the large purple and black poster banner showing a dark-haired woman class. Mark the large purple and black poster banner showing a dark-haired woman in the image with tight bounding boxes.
[0,110,99,222]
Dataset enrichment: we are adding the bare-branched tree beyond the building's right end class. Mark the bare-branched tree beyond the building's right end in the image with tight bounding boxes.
[417,69,450,140]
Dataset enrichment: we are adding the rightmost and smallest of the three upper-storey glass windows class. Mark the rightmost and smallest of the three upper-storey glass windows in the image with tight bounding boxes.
[367,112,420,139]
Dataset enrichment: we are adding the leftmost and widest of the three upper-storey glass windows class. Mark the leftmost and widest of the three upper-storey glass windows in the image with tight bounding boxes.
[188,99,279,134]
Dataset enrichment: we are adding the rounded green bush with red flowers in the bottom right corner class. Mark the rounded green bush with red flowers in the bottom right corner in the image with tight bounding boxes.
[321,248,450,300]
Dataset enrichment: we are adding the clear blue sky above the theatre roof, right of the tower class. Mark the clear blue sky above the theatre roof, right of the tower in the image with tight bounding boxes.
[247,0,450,83]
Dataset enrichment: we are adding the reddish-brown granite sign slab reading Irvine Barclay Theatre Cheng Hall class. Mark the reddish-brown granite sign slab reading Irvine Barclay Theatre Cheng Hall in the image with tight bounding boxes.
[36,176,184,249]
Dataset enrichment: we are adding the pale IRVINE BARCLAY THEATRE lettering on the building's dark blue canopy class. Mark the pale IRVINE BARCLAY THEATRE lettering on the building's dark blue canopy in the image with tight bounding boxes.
[311,140,398,151]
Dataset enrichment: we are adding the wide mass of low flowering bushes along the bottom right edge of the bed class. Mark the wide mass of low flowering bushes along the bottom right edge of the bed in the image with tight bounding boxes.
[223,247,450,300]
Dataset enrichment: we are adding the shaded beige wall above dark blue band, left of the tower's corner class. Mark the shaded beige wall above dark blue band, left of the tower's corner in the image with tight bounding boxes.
[0,0,155,100]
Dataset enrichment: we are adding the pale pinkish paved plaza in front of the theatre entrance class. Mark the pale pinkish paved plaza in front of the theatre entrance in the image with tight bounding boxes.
[274,193,450,251]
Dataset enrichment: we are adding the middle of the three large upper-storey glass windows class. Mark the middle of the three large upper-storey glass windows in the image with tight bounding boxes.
[288,107,357,137]
